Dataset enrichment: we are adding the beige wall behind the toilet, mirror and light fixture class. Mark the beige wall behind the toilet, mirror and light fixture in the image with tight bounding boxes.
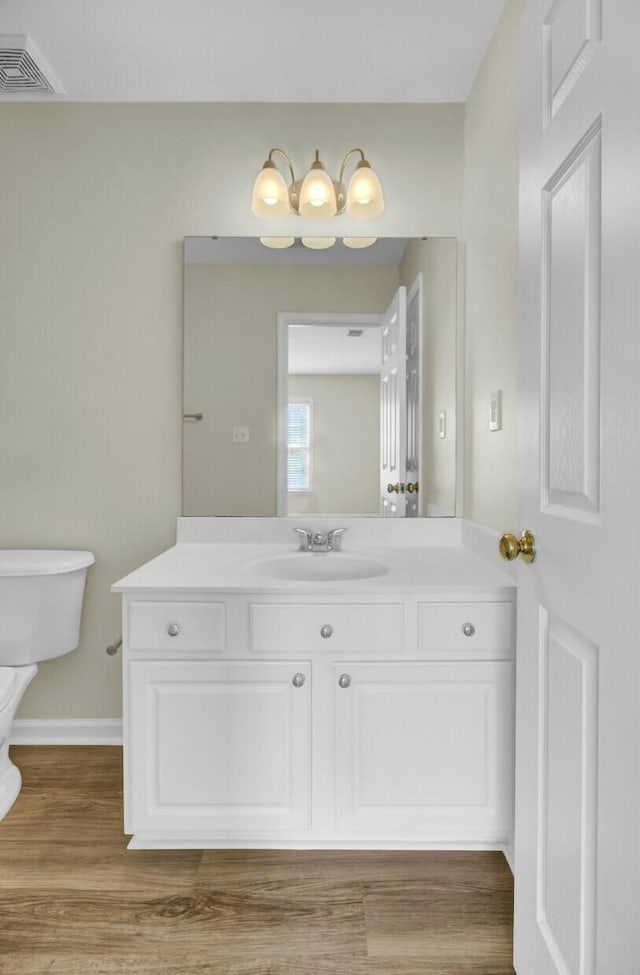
[0,104,463,718]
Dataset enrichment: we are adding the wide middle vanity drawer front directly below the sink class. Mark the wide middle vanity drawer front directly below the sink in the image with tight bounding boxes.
[250,603,404,653]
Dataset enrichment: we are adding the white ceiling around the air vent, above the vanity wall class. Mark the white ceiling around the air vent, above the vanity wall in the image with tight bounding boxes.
[0,0,504,103]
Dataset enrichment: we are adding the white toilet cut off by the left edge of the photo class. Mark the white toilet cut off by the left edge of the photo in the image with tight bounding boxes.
[0,549,95,819]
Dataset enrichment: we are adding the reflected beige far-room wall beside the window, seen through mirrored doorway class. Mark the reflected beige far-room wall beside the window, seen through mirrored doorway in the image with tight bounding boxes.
[288,375,380,515]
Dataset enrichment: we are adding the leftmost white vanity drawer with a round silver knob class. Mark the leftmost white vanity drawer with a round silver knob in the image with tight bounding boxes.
[128,602,225,651]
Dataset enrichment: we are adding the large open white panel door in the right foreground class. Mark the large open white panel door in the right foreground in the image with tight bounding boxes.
[515,0,640,975]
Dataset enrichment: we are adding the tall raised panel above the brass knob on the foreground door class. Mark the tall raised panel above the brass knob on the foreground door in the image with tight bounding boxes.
[540,117,602,521]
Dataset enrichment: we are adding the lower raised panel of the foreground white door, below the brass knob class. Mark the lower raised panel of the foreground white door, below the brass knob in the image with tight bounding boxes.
[536,607,598,975]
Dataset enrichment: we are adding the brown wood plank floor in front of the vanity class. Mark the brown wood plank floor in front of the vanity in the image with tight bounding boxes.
[0,746,513,975]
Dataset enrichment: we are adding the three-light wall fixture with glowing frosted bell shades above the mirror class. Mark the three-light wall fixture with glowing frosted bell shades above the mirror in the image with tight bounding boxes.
[251,147,384,219]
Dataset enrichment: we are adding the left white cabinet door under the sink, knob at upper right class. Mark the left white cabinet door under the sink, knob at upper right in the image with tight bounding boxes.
[126,661,310,834]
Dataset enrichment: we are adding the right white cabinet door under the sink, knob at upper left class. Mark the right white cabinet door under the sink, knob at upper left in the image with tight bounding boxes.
[334,662,513,842]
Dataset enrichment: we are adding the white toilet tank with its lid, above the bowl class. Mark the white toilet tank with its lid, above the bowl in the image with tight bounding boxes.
[0,549,95,667]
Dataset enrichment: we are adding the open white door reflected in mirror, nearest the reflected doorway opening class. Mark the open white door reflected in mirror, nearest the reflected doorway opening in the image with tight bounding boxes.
[380,288,407,518]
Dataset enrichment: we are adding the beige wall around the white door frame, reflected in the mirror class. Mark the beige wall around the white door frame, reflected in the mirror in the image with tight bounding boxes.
[183,264,398,516]
